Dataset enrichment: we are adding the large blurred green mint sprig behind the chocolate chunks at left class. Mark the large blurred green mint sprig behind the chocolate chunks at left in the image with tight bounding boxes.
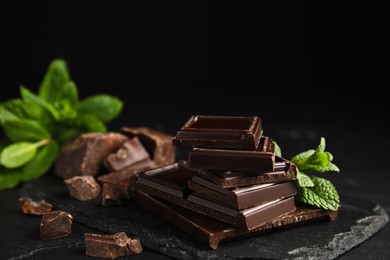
[0,59,123,190]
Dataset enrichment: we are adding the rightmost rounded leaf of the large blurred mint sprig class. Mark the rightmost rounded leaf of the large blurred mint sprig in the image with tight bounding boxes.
[78,94,123,122]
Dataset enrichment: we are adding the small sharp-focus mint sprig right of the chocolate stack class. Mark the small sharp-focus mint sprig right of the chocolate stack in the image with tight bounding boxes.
[290,137,340,211]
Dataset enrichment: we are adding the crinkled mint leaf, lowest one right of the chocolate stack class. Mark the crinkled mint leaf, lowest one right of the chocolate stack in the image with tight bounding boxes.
[295,176,340,211]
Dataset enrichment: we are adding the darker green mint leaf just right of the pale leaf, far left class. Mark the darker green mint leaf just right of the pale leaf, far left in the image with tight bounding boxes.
[21,141,58,181]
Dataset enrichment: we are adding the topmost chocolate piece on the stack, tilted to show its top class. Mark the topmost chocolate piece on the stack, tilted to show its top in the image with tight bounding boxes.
[172,115,263,150]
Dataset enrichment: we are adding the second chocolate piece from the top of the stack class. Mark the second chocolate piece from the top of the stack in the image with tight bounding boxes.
[188,148,275,173]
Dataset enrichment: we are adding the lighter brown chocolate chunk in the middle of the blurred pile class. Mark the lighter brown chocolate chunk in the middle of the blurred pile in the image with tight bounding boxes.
[104,137,149,171]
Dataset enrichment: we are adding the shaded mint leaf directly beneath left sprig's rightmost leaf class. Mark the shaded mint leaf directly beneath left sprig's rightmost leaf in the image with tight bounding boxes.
[63,113,107,132]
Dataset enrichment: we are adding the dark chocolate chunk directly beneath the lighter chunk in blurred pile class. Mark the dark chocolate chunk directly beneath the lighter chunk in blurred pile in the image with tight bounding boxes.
[98,158,157,199]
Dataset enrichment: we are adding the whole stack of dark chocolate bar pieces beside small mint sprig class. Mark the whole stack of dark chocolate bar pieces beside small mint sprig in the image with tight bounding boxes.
[136,116,331,249]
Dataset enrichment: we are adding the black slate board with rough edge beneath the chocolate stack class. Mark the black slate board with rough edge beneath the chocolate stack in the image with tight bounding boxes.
[14,176,389,259]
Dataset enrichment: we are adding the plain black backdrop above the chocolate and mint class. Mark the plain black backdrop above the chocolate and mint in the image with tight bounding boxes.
[0,1,388,132]
